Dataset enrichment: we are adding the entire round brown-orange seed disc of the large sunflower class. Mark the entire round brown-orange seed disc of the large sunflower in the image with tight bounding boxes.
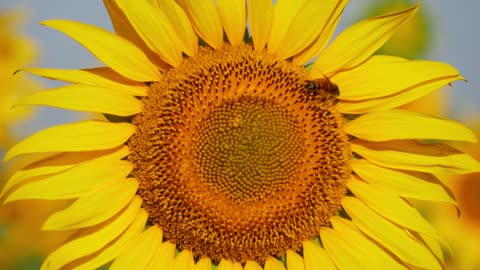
[128,45,351,263]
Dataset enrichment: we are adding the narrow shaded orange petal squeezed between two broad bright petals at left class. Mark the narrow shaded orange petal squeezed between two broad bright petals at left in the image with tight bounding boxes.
[0,146,130,197]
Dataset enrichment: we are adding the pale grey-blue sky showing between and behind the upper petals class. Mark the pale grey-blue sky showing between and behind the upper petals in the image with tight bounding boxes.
[0,0,480,137]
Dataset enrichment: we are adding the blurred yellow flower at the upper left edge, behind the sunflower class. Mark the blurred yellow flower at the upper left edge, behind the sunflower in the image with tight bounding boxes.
[0,10,39,149]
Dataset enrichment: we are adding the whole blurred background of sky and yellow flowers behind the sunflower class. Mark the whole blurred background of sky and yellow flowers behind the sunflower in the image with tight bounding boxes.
[0,0,480,270]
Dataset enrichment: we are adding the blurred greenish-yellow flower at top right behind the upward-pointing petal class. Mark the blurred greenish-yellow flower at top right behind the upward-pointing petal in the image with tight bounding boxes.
[366,0,435,59]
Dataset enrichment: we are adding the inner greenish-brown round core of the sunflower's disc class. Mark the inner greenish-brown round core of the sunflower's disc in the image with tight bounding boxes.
[193,97,304,203]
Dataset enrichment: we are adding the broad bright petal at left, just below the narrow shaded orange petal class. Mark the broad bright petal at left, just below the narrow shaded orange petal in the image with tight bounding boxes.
[5,160,133,202]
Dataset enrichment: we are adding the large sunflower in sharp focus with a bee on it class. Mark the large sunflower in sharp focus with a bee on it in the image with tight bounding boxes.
[2,0,480,270]
